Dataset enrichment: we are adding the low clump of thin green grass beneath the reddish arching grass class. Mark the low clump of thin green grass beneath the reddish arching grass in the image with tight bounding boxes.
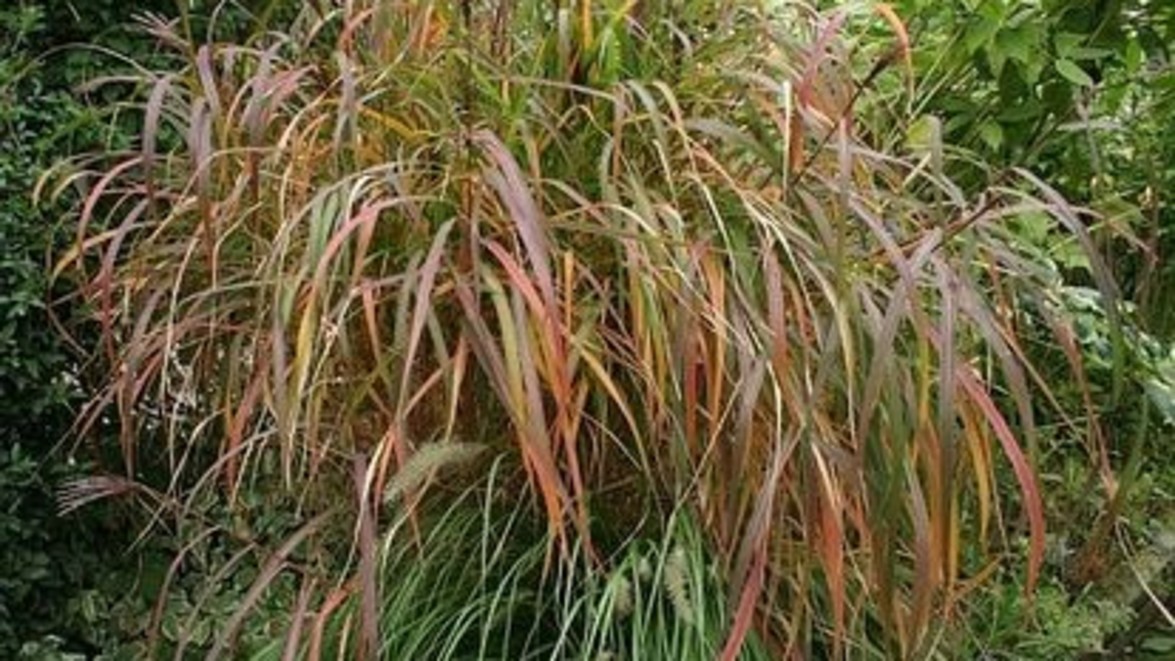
[273,453,770,661]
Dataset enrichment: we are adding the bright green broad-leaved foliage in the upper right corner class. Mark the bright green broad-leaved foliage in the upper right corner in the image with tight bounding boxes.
[895,0,1175,337]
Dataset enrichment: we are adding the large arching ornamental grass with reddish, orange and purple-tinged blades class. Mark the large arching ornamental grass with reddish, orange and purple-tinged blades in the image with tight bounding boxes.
[56,0,1114,659]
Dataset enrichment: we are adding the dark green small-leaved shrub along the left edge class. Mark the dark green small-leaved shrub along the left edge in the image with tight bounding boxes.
[0,1,171,659]
